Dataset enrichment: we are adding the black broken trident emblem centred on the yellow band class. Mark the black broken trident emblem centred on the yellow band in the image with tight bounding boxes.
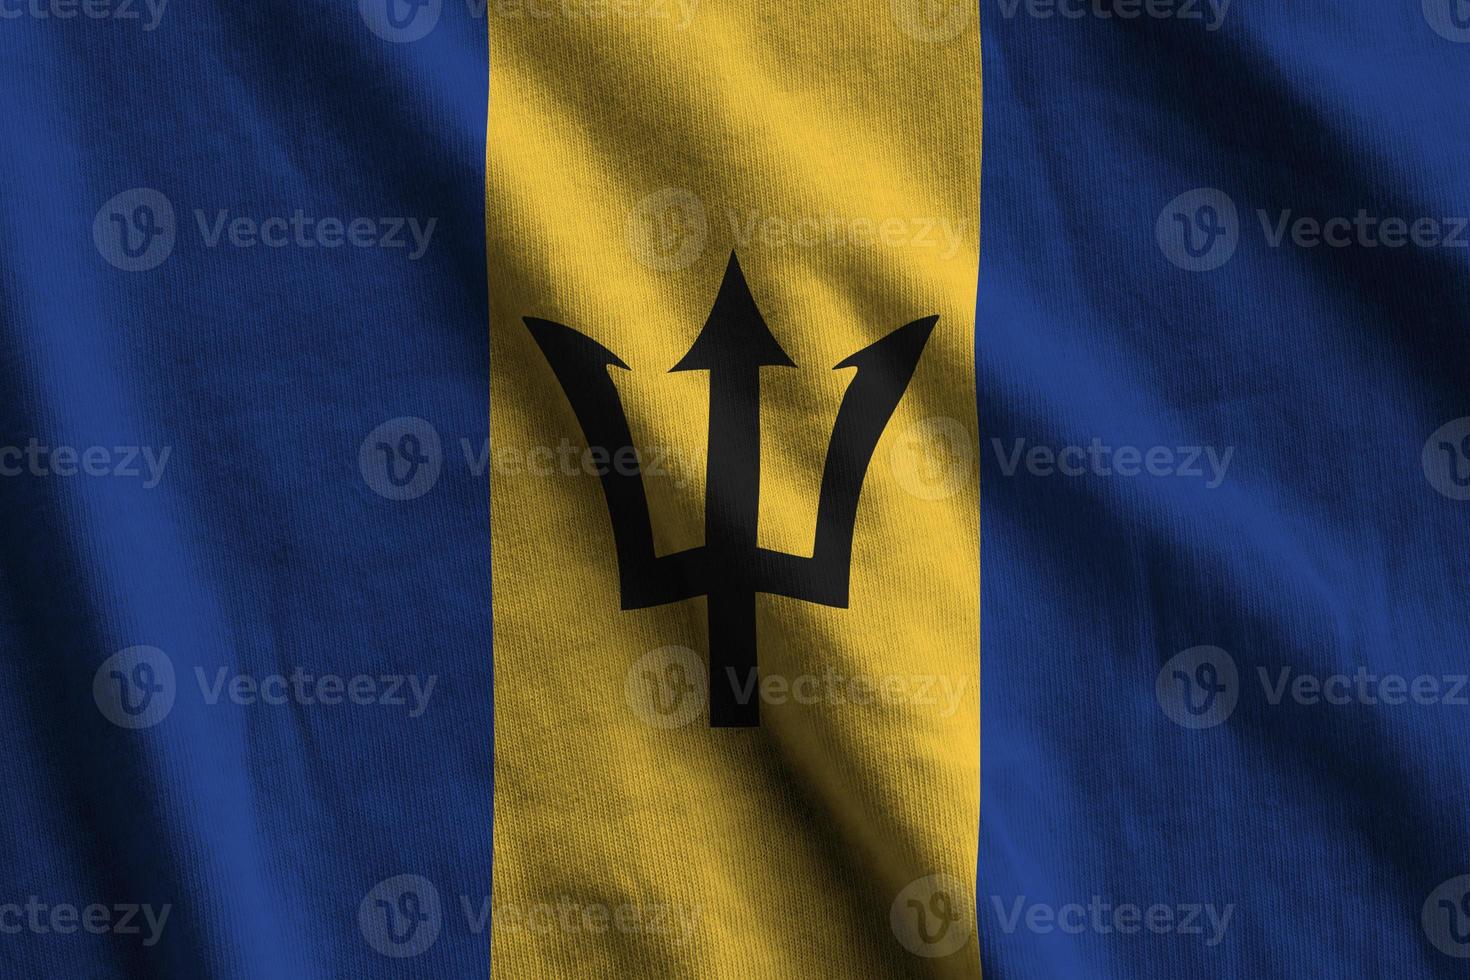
[525,254,939,727]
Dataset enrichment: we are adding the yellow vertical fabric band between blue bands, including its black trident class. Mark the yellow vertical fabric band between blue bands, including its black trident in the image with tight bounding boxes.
[487,0,980,980]
